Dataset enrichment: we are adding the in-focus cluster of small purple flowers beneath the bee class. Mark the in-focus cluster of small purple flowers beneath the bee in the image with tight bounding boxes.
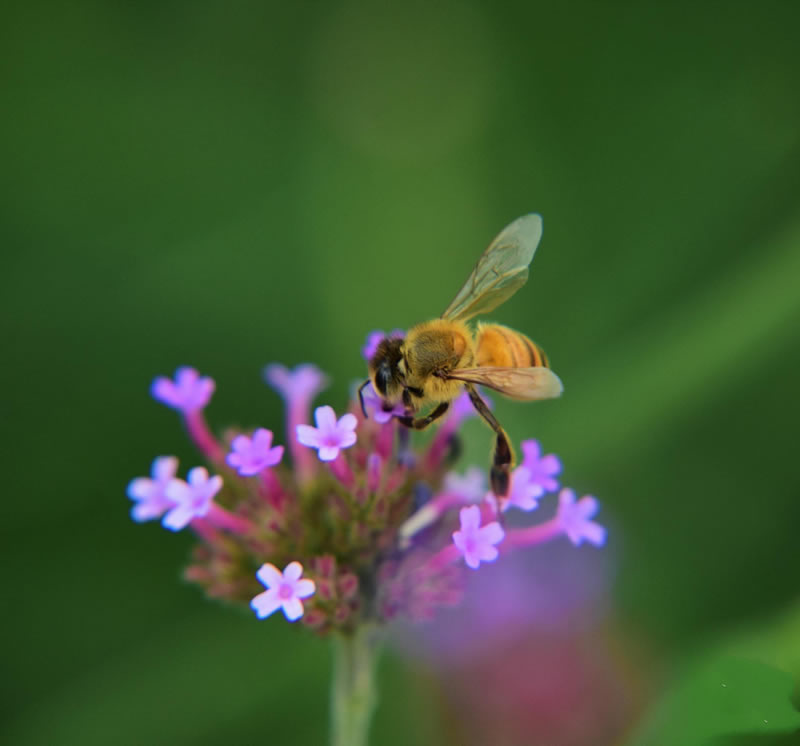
[128,336,605,633]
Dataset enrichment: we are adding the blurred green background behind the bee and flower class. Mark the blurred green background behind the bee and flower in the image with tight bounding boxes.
[0,0,800,746]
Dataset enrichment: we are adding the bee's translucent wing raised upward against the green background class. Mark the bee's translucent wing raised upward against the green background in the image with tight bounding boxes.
[442,213,542,321]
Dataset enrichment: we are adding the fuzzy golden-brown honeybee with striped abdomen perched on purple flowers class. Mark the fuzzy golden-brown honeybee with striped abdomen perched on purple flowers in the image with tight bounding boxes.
[359,214,563,498]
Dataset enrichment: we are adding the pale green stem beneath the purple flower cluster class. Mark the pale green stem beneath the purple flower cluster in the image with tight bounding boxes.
[331,625,379,746]
